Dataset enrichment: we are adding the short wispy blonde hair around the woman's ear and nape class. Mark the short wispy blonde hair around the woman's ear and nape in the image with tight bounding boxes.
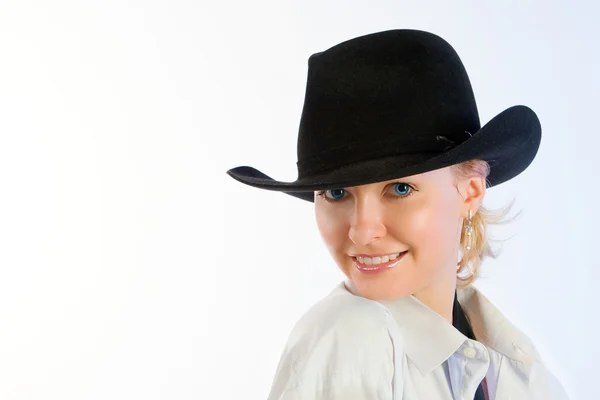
[450,159,520,288]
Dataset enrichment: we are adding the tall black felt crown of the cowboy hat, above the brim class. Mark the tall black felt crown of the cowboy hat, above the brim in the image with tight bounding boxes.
[297,29,481,177]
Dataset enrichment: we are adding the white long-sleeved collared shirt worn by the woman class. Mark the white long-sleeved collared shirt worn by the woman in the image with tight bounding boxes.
[268,280,568,400]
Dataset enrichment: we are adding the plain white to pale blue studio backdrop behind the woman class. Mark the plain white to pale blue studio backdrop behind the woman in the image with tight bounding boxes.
[0,0,600,400]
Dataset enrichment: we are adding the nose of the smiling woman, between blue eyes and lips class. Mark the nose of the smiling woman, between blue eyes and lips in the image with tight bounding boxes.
[348,196,387,248]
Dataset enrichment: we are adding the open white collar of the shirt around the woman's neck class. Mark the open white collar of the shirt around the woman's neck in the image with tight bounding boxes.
[340,279,539,376]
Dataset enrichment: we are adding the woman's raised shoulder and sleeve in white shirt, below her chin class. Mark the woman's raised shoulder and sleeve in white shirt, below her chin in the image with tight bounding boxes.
[269,291,394,399]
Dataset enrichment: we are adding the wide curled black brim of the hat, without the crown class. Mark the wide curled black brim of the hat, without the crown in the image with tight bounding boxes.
[227,105,541,202]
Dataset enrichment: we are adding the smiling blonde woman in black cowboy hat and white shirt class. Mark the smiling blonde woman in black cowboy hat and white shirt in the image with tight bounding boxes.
[227,29,567,400]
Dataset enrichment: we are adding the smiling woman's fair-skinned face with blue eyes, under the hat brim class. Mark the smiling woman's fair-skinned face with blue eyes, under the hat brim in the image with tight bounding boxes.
[315,167,485,300]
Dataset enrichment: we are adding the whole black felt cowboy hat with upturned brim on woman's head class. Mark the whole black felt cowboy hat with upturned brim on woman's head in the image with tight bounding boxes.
[227,29,541,202]
